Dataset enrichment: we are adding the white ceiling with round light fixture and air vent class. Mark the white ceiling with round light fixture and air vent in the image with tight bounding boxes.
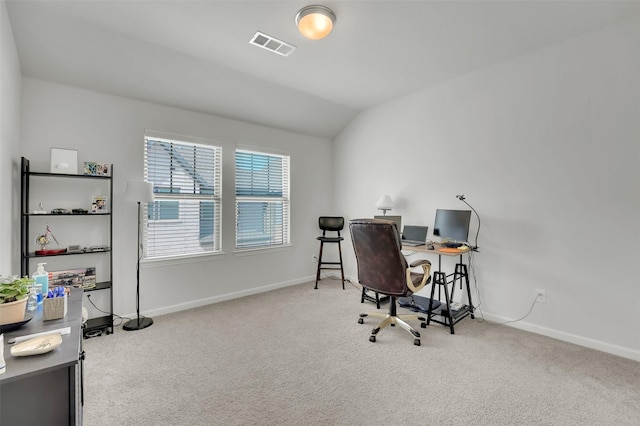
[6,0,640,138]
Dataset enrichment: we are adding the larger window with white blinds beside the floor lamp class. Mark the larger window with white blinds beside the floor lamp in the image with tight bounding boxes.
[145,136,222,258]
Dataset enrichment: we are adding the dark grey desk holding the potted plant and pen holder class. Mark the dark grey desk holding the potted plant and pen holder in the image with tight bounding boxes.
[0,288,83,426]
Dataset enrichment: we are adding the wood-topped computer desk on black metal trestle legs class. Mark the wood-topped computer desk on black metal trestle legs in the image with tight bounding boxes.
[402,244,475,334]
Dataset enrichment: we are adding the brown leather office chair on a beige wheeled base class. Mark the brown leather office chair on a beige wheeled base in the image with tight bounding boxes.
[349,219,431,346]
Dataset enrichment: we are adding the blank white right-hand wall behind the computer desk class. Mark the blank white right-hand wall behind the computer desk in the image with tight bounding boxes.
[335,17,640,359]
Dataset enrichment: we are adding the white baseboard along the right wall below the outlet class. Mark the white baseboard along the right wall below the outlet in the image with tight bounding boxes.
[483,313,640,361]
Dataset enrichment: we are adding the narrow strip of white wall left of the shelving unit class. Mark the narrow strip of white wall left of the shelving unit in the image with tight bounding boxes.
[0,0,21,276]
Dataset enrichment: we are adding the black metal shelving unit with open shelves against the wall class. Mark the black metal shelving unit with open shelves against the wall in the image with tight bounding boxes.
[20,157,113,334]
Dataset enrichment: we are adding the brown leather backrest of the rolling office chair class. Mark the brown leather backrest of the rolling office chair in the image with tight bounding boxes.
[349,219,411,296]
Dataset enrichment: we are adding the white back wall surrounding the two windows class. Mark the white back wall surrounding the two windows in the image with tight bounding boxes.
[16,78,333,316]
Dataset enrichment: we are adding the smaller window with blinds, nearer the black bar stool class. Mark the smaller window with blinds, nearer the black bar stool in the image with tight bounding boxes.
[236,150,290,249]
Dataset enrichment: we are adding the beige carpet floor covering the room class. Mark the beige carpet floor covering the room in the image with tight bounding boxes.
[84,279,640,426]
